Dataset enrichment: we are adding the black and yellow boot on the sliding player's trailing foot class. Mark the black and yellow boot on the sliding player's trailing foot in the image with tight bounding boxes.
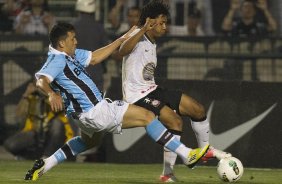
[24,159,45,181]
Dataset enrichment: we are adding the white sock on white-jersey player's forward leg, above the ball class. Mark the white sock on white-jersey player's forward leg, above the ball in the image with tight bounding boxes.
[191,119,210,148]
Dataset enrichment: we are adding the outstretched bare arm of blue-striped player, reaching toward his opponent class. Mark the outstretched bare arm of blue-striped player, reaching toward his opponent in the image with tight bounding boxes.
[90,26,136,65]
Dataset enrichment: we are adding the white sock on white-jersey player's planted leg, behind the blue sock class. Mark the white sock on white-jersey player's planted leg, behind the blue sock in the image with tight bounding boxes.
[163,135,181,175]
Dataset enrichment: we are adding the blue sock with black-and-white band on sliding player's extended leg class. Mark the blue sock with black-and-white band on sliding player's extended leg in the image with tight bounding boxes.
[146,119,182,152]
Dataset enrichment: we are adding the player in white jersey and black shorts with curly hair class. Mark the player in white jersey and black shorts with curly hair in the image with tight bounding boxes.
[119,0,231,182]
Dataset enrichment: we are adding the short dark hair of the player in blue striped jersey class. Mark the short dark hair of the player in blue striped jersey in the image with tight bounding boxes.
[49,22,75,48]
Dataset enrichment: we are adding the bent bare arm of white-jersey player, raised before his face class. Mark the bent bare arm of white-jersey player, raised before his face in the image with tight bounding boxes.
[119,18,156,56]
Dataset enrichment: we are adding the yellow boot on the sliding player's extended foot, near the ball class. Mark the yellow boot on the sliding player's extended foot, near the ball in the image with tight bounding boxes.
[185,144,210,168]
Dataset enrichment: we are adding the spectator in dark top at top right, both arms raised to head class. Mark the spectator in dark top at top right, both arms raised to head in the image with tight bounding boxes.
[222,0,277,37]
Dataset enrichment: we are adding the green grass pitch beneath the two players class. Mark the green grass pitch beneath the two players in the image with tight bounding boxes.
[0,160,282,184]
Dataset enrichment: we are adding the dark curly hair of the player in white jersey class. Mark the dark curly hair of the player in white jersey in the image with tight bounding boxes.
[138,0,170,27]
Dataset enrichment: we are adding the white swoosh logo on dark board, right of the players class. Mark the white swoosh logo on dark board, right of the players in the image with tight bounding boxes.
[207,102,277,150]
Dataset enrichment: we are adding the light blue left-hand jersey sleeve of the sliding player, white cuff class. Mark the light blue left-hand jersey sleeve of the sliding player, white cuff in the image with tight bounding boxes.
[35,55,66,82]
